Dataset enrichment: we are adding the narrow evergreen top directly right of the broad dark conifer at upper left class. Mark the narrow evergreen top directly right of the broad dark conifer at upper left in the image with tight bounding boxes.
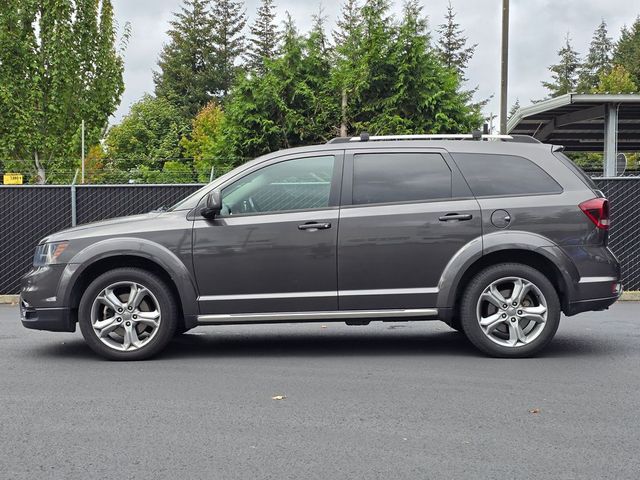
[211,0,247,98]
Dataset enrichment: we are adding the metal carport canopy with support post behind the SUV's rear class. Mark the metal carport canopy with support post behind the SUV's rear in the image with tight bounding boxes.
[507,93,640,152]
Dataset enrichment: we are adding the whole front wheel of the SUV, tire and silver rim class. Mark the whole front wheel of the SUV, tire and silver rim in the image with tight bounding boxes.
[78,268,177,360]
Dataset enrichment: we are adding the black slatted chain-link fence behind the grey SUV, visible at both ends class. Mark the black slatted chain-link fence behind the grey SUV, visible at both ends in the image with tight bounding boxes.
[0,177,640,294]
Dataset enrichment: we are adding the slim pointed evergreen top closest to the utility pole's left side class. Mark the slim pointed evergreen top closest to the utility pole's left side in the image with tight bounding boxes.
[436,1,478,81]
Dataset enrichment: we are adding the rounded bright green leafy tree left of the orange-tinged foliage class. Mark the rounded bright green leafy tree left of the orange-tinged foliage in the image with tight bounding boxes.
[105,95,188,171]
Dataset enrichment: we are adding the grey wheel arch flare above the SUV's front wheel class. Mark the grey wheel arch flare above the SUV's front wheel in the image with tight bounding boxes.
[58,237,198,320]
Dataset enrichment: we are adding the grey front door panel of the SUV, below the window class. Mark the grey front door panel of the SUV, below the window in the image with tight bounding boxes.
[193,209,338,313]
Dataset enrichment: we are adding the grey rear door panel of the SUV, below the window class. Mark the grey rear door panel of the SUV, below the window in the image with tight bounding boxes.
[338,199,481,309]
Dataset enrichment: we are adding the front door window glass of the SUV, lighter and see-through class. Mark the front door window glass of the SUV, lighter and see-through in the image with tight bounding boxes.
[222,155,335,215]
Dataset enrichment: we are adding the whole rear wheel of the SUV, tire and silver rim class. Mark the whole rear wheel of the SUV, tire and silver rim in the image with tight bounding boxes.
[461,263,560,358]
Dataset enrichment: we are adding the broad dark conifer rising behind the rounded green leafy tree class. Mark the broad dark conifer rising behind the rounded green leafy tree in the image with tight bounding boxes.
[154,0,219,118]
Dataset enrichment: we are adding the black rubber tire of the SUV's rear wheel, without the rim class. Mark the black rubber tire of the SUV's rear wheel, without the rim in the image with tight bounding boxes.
[460,263,561,358]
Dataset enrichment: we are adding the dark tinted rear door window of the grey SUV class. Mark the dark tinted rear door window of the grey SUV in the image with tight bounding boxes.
[353,153,451,205]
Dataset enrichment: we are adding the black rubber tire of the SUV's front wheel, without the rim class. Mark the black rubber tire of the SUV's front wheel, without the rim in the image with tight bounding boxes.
[78,268,178,360]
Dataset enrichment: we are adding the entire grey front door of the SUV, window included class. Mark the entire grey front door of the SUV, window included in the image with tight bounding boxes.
[193,152,342,314]
